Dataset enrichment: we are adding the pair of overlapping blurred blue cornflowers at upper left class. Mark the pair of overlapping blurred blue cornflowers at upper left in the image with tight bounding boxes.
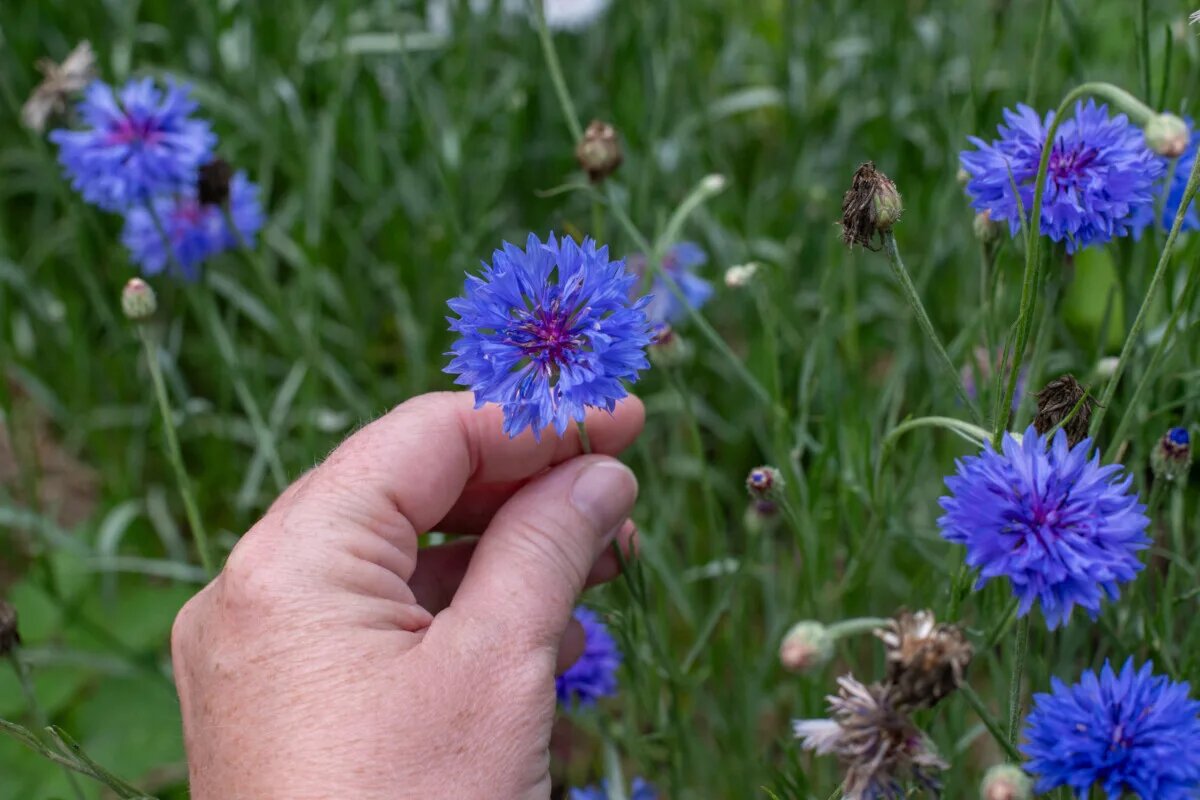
[49,78,263,279]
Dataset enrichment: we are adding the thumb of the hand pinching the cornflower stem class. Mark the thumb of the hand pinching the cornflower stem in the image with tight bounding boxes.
[451,456,637,646]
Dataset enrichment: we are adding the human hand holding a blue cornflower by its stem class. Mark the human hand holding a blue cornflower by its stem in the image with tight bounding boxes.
[172,392,644,800]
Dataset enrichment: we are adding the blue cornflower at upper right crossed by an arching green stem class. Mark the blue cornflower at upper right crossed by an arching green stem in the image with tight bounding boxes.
[959,101,1165,253]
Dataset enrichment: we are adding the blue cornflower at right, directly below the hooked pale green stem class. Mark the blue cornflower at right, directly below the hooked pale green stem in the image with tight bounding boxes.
[937,426,1150,630]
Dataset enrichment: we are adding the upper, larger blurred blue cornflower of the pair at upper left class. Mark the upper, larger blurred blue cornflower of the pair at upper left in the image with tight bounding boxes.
[50,78,217,211]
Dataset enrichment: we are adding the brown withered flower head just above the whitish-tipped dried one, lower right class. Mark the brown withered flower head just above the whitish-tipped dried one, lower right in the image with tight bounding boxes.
[875,610,974,709]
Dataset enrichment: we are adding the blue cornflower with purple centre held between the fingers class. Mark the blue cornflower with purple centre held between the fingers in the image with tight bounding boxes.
[445,234,650,438]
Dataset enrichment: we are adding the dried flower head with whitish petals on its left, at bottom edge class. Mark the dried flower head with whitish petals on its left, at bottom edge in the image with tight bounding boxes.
[792,675,947,800]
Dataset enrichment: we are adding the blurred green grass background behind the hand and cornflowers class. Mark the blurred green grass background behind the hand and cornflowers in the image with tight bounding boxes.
[0,0,1200,800]
